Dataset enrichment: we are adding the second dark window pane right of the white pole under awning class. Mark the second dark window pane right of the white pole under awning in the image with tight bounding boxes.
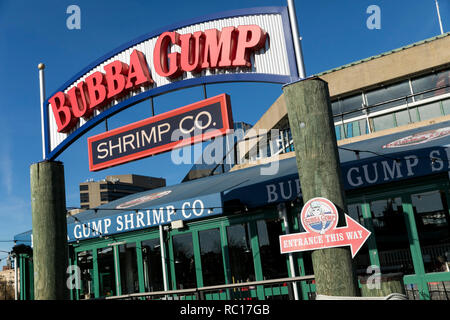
[198,229,225,286]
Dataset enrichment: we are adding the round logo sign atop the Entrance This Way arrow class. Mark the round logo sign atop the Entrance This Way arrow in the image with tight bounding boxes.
[300,198,338,234]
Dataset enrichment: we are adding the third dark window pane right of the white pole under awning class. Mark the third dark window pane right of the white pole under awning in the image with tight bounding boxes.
[227,223,255,283]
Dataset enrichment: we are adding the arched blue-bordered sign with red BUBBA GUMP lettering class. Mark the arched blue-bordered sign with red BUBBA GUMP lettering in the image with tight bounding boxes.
[43,7,298,160]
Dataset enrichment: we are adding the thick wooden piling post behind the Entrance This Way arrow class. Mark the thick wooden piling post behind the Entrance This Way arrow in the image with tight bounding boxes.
[283,77,358,296]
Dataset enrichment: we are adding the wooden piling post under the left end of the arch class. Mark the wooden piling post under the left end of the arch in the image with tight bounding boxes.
[30,161,68,300]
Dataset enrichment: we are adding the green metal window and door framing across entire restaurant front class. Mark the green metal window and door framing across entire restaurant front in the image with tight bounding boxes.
[18,174,450,300]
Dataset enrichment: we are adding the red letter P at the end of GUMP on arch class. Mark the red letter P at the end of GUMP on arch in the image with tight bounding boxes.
[233,25,267,67]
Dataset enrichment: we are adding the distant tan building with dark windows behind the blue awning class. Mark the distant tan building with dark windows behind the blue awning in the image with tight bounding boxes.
[80,174,166,209]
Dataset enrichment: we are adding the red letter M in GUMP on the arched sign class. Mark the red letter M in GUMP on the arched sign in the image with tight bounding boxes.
[202,27,236,68]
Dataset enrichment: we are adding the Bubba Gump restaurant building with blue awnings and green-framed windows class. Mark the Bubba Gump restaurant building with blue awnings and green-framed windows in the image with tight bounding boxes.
[15,29,450,299]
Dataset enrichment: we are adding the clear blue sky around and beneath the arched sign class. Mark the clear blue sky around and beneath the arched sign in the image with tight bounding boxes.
[0,0,450,265]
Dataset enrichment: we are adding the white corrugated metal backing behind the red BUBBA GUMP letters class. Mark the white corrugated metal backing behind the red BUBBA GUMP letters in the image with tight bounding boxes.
[48,14,290,151]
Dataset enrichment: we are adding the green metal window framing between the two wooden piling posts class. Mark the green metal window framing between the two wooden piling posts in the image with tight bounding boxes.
[67,207,307,299]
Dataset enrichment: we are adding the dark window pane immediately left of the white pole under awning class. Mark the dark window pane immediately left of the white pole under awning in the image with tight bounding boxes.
[141,239,164,292]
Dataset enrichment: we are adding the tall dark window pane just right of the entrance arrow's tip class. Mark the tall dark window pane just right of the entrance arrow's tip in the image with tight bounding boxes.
[370,198,414,274]
